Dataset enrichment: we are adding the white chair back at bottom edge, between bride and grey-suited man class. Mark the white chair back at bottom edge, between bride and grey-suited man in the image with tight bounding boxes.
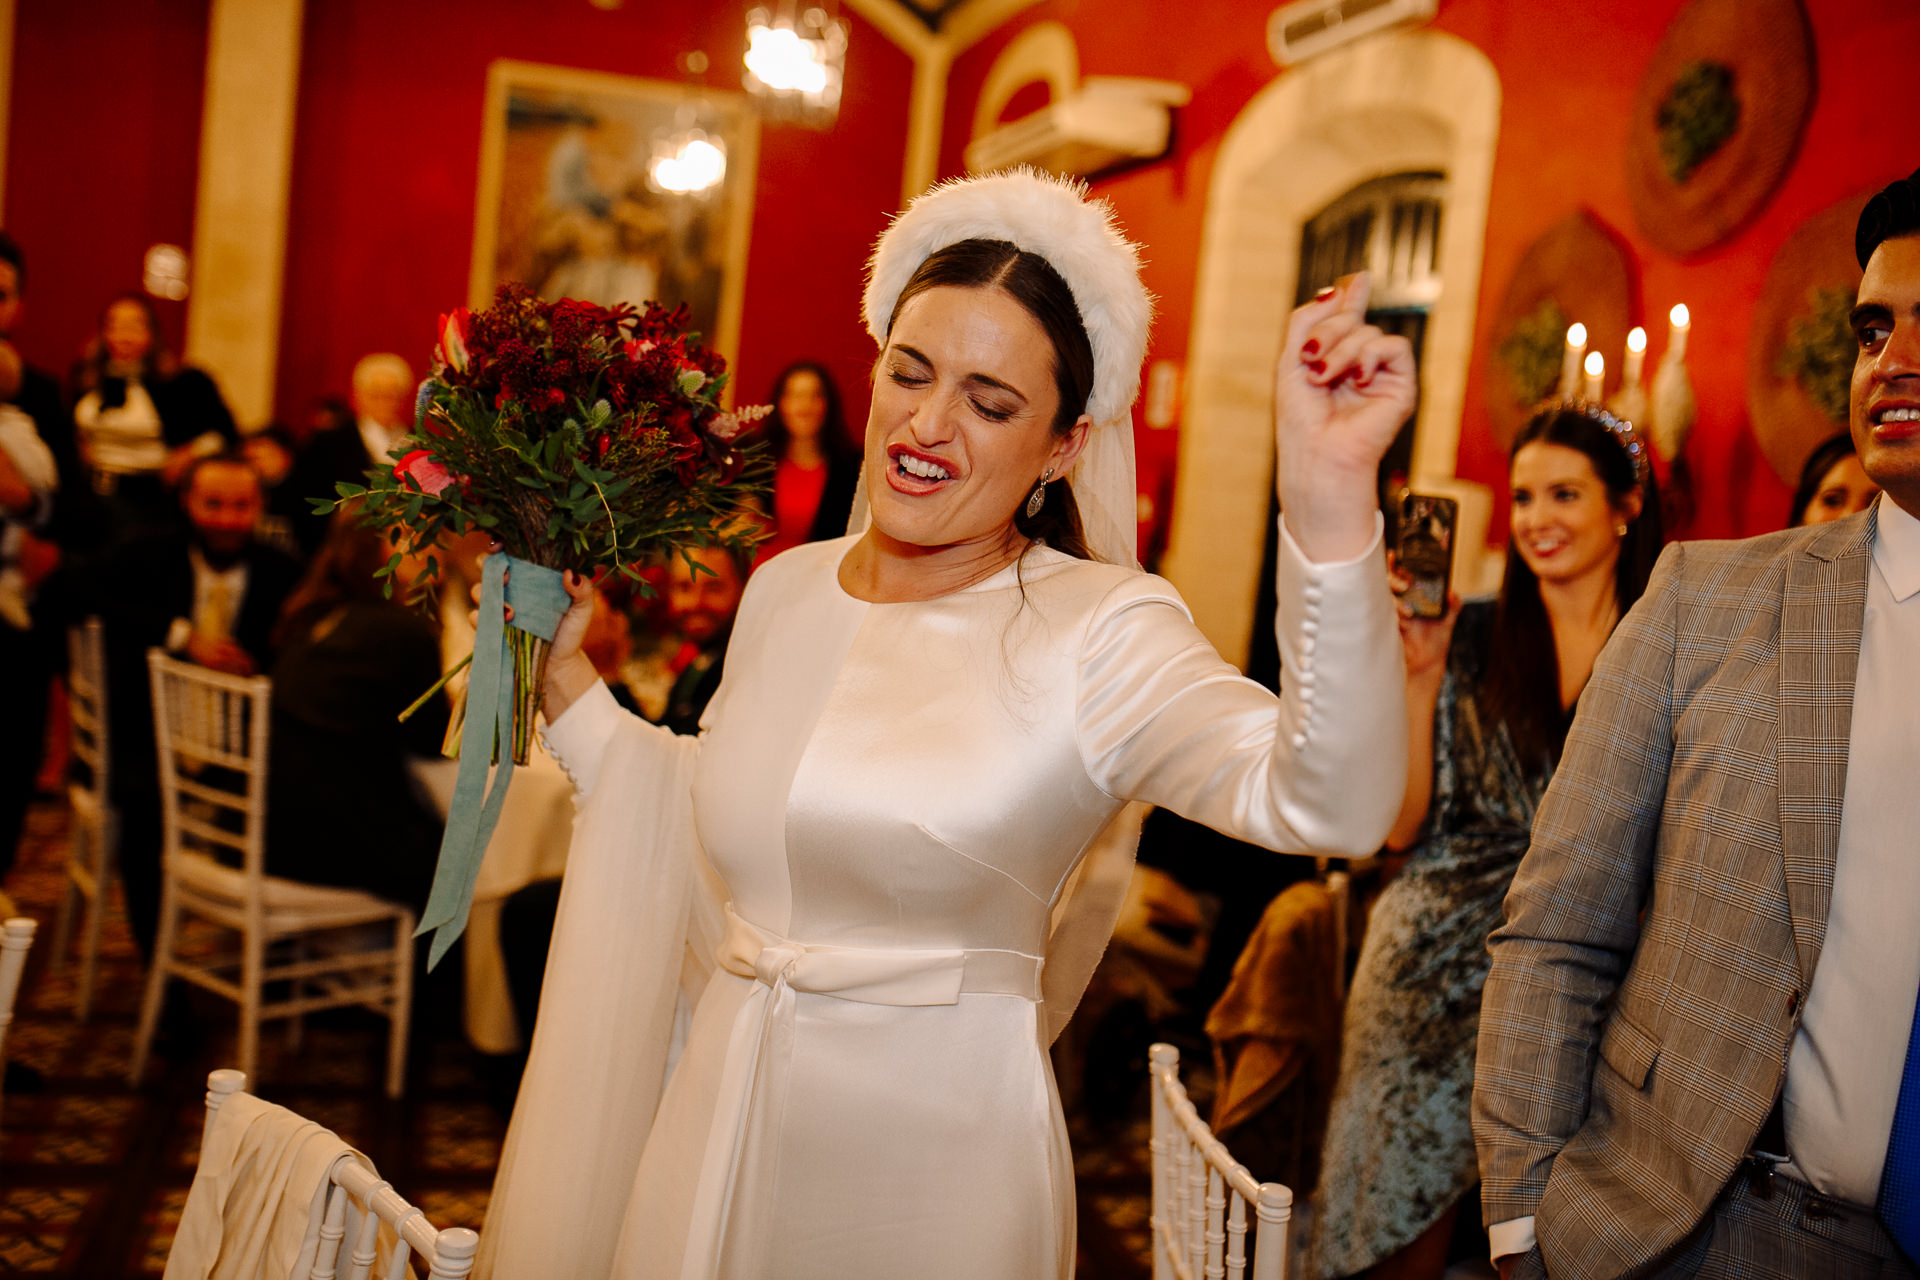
[1148,1044,1294,1280]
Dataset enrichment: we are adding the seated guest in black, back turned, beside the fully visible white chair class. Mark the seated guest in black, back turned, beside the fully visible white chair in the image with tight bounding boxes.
[267,509,447,912]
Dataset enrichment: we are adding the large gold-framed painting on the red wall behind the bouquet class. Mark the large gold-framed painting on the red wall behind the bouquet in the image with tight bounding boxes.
[467,59,760,376]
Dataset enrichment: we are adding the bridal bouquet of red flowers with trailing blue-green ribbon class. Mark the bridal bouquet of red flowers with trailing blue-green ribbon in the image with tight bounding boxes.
[340,284,772,960]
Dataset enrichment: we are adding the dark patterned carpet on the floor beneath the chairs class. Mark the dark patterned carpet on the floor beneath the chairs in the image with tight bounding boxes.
[0,804,1159,1280]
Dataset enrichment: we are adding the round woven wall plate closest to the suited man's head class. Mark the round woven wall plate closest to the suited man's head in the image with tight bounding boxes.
[1747,188,1878,484]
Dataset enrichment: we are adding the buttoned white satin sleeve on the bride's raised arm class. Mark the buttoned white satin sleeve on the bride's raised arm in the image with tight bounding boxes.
[1077,524,1407,856]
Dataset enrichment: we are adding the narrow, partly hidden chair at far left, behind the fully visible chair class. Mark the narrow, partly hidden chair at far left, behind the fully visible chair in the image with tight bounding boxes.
[50,618,119,1023]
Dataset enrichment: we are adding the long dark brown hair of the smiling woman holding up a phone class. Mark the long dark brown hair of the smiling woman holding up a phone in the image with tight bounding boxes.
[1480,407,1665,768]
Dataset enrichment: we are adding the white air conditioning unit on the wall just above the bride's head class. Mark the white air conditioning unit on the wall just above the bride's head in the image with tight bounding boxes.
[966,75,1192,177]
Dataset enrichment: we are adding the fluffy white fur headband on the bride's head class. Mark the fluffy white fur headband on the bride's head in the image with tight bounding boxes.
[860,169,1154,426]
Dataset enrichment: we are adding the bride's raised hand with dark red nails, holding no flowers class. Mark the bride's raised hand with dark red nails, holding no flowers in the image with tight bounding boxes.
[1275,271,1417,562]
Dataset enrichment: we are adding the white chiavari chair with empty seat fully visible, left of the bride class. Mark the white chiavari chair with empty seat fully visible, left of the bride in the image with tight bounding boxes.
[127,649,415,1098]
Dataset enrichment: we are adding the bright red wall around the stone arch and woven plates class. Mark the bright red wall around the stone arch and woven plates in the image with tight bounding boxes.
[941,0,1920,537]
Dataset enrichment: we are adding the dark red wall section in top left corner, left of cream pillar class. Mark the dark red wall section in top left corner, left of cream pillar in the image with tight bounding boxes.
[4,0,207,374]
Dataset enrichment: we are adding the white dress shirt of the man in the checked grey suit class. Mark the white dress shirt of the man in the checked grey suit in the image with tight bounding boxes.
[1488,495,1920,1259]
